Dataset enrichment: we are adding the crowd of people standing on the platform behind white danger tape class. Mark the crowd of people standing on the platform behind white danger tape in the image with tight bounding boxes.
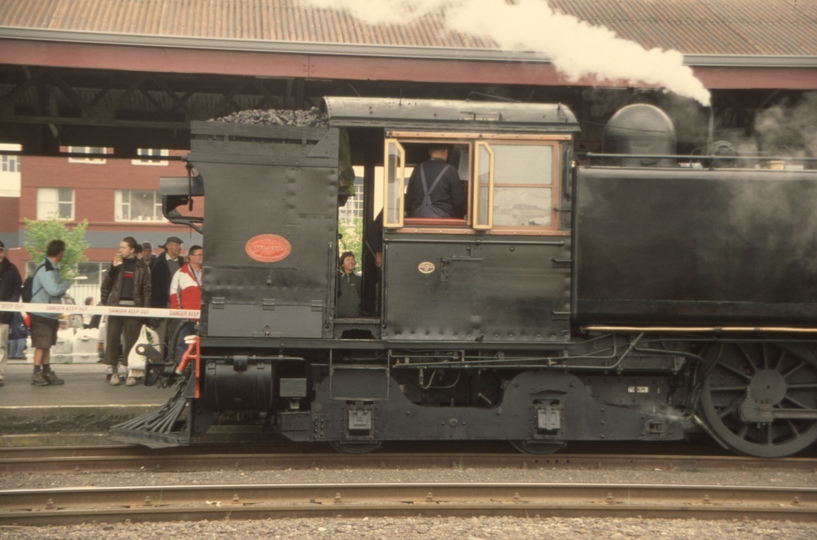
[0,236,204,386]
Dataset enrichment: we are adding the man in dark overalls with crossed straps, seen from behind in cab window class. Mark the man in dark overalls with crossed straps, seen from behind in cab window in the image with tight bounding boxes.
[406,145,465,219]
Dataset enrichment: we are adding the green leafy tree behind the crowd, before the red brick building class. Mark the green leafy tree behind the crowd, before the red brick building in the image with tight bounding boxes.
[25,219,91,280]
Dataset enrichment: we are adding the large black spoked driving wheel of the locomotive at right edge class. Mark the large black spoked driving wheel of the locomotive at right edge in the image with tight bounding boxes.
[699,343,817,458]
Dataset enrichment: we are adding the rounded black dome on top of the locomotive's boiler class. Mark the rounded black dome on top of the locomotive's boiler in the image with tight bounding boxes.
[601,104,676,167]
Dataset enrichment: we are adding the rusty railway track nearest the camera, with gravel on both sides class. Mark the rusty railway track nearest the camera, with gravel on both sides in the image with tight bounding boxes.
[0,483,817,526]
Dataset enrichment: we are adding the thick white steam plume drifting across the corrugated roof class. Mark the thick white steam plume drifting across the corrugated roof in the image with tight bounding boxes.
[301,0,709,106]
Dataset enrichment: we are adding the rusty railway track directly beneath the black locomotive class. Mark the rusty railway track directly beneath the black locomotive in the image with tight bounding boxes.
[0,446,817,473]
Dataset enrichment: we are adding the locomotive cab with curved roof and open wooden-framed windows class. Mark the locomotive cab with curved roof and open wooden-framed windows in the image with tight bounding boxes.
[326,98,579,344]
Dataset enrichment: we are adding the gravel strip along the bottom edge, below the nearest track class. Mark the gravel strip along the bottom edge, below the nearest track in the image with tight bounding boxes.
[0,517,817,540]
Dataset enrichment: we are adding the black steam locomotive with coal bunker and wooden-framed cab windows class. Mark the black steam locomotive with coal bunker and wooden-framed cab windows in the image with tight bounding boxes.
[111,98,817,457]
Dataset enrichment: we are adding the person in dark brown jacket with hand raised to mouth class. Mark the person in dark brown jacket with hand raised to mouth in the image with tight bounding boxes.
[100,236,151,386]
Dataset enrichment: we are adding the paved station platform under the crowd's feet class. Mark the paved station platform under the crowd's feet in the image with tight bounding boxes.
[0,360,174,446]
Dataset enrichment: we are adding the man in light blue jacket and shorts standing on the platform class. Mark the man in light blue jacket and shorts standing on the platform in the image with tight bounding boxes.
[31,240,71,386]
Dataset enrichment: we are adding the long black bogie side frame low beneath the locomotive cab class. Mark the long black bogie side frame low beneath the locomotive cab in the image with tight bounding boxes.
[280,372,685,442]
